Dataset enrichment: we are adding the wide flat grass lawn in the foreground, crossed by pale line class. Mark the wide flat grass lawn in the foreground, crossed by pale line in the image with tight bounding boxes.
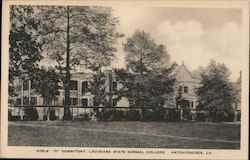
[8,121,240,149]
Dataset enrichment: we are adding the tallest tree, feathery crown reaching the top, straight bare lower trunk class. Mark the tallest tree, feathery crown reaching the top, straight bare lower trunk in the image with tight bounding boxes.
[36,6,122,119]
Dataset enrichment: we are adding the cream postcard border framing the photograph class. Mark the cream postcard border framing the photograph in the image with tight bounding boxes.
[0,0,249,160]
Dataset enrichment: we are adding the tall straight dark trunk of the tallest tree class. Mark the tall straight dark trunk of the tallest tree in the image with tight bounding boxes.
[63,6,71,120]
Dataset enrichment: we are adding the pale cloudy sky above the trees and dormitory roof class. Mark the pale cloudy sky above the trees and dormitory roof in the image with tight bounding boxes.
[112,7,242,81]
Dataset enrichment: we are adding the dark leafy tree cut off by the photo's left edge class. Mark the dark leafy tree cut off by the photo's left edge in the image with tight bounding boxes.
[9,5,43,95]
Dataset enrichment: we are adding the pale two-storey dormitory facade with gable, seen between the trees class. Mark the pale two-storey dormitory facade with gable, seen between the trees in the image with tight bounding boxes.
[9,64,203,120]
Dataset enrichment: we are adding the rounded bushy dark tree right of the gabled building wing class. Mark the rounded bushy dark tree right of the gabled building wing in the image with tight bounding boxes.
[197,60,235,121]
